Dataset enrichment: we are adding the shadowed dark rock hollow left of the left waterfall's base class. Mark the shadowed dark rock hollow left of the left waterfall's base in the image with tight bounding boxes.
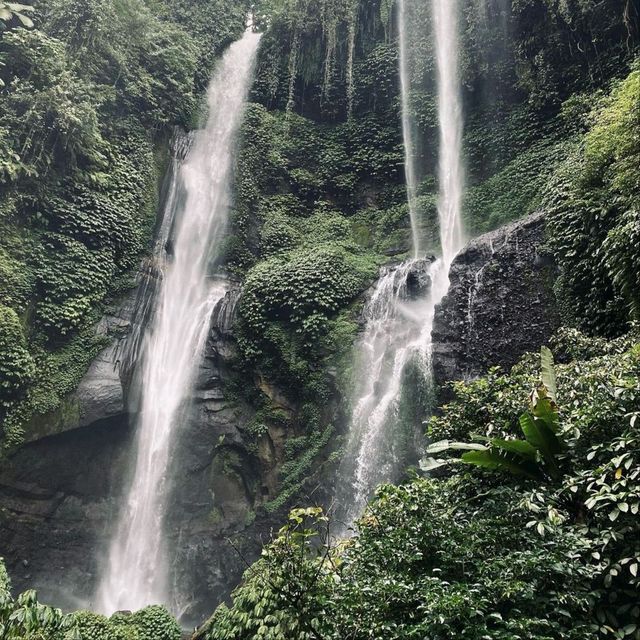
[0,416,131,609]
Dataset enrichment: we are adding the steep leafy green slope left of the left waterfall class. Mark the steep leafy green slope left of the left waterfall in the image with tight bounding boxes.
[0,0,246,451]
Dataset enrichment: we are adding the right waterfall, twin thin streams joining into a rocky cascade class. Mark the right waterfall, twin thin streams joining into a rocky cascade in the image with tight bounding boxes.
[336,0,464,527]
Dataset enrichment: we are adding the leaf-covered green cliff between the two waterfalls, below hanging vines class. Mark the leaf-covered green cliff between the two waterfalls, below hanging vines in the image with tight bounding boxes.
[226,96,408,511]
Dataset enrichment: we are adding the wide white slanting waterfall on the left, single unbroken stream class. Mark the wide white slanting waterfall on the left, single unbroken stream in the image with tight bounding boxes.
[97,32,259,613]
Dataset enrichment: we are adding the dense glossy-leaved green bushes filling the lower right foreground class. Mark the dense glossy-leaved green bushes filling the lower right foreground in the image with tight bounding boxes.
[206,330,640,640]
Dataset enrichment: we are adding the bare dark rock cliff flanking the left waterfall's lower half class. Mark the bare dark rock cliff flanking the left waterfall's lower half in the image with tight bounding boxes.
[0,286,285,622]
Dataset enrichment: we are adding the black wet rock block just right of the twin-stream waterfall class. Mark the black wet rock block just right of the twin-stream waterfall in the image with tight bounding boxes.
[433,213,560,399]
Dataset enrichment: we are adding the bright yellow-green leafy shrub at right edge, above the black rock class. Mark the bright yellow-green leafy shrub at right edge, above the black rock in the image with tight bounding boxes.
[546,70,640,337]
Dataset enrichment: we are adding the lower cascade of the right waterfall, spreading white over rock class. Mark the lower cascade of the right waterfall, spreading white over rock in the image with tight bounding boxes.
[336,259,447,533]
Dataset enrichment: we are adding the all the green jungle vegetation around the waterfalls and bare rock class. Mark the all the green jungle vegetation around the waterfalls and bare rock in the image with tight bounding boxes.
[0,0,640,640]
